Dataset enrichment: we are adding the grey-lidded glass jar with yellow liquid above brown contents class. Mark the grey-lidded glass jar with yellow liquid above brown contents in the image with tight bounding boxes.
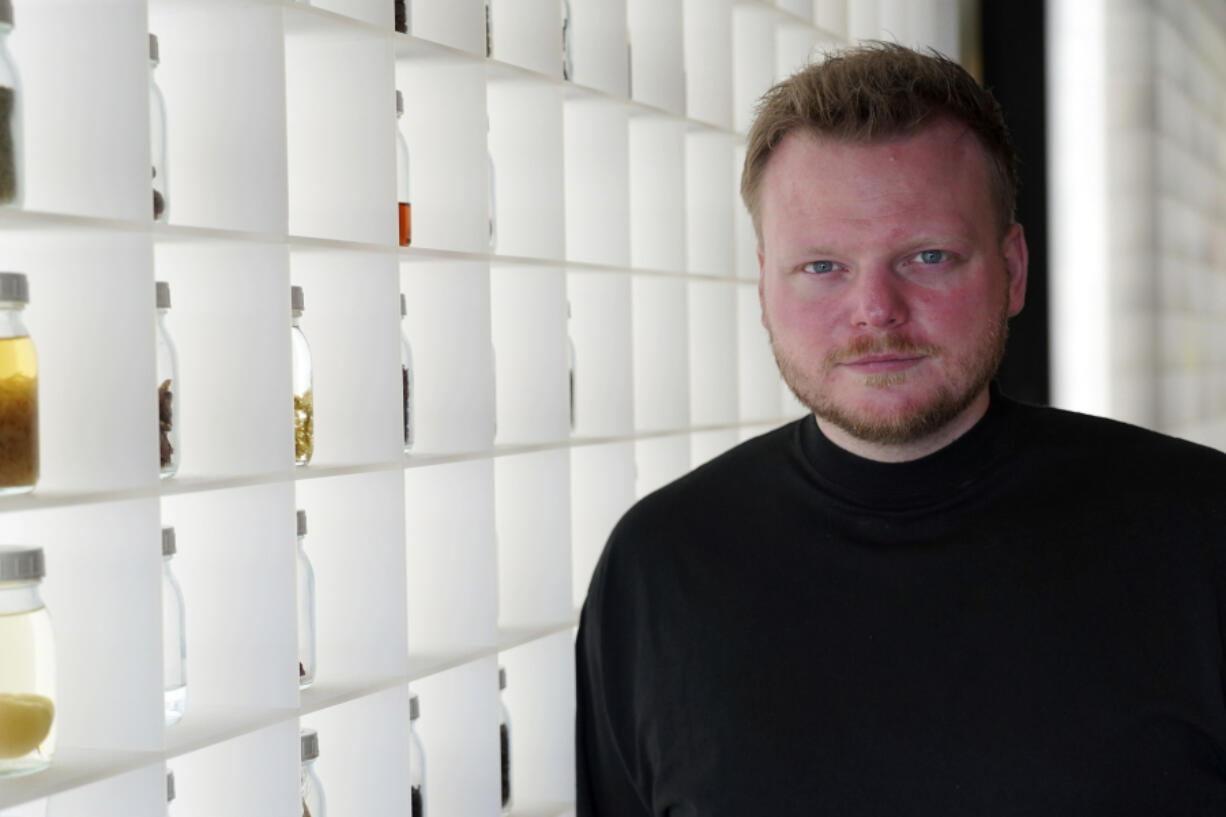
[0,269,38,496]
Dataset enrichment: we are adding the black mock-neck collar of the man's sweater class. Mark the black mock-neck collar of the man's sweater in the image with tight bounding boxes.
[799,382,1018,510]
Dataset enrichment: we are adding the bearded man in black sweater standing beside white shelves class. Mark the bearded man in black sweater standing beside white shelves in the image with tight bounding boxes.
[576,44,1226,817]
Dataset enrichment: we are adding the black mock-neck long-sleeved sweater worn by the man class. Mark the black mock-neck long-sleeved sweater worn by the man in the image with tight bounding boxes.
[576,391,1226,817]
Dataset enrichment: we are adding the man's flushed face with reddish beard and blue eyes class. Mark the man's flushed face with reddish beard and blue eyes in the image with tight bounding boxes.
[758,120,1026,447]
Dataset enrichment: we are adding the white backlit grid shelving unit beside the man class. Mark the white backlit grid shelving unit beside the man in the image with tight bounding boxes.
[0,0,949,817]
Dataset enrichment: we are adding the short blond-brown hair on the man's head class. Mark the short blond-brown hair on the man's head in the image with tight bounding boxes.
[741,42,1018,244]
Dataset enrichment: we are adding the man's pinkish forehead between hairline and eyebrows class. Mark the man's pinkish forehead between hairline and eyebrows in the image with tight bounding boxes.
[760,120,994,243]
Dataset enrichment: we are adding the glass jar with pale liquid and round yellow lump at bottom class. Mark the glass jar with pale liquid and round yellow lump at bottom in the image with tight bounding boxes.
[0,547,55,777]
